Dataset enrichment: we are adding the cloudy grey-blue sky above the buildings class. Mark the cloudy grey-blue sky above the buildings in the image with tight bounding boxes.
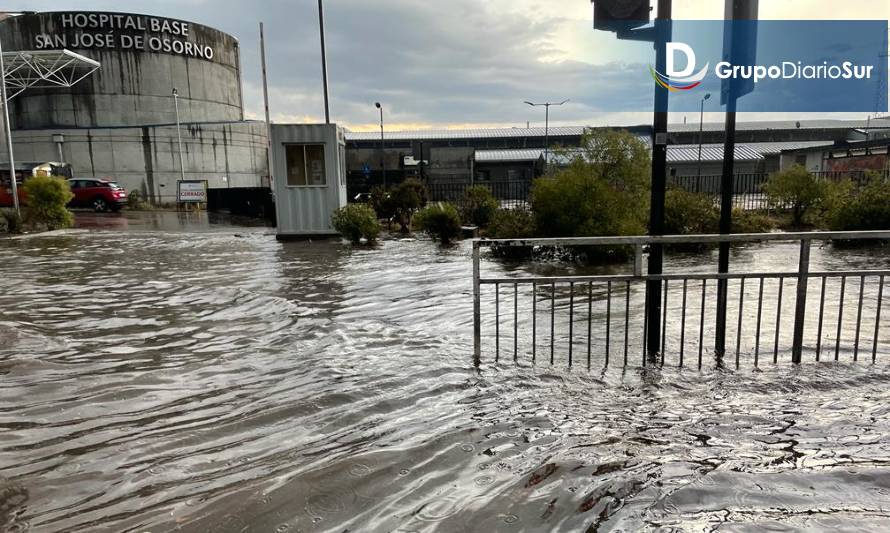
[5,0,890,130]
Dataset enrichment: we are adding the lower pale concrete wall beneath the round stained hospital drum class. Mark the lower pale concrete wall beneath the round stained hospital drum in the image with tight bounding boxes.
[10,122,268,203]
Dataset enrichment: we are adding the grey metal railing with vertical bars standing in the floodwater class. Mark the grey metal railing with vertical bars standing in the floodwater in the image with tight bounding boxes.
[473,231,890,368]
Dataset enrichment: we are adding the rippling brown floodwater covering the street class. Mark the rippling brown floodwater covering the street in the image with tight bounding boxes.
[0,213,890,532]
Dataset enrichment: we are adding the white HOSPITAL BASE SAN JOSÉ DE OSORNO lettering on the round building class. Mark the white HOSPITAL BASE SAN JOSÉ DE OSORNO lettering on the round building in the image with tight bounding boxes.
[33,13,216,60]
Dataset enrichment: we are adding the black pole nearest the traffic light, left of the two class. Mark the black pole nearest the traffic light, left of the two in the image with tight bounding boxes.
[646,0,671,361]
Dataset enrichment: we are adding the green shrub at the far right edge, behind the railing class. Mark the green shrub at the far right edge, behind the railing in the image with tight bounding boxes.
[825,177,890,231]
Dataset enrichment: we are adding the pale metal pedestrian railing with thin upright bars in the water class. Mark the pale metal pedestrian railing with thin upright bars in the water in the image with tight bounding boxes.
[473,231,890,367]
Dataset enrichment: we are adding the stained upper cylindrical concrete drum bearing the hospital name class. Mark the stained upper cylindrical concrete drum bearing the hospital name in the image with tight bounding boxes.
[0,12,244,129]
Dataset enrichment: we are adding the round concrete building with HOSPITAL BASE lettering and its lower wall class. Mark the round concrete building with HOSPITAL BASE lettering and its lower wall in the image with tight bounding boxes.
[0,12,271,211]
